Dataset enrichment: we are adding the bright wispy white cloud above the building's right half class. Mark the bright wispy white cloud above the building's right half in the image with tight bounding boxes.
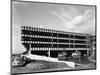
[51,8,95,34]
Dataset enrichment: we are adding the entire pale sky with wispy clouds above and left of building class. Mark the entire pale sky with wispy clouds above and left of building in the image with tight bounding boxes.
[12,1,95,54]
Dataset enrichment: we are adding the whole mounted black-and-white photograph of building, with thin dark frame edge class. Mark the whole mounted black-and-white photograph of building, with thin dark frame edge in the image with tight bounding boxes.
[11,0,96,74]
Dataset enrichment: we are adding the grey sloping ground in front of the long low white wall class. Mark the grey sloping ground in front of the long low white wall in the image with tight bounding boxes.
[12,61,71,73]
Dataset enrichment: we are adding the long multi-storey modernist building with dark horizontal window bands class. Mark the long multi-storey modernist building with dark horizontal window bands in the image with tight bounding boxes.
[21,26,91,57]
